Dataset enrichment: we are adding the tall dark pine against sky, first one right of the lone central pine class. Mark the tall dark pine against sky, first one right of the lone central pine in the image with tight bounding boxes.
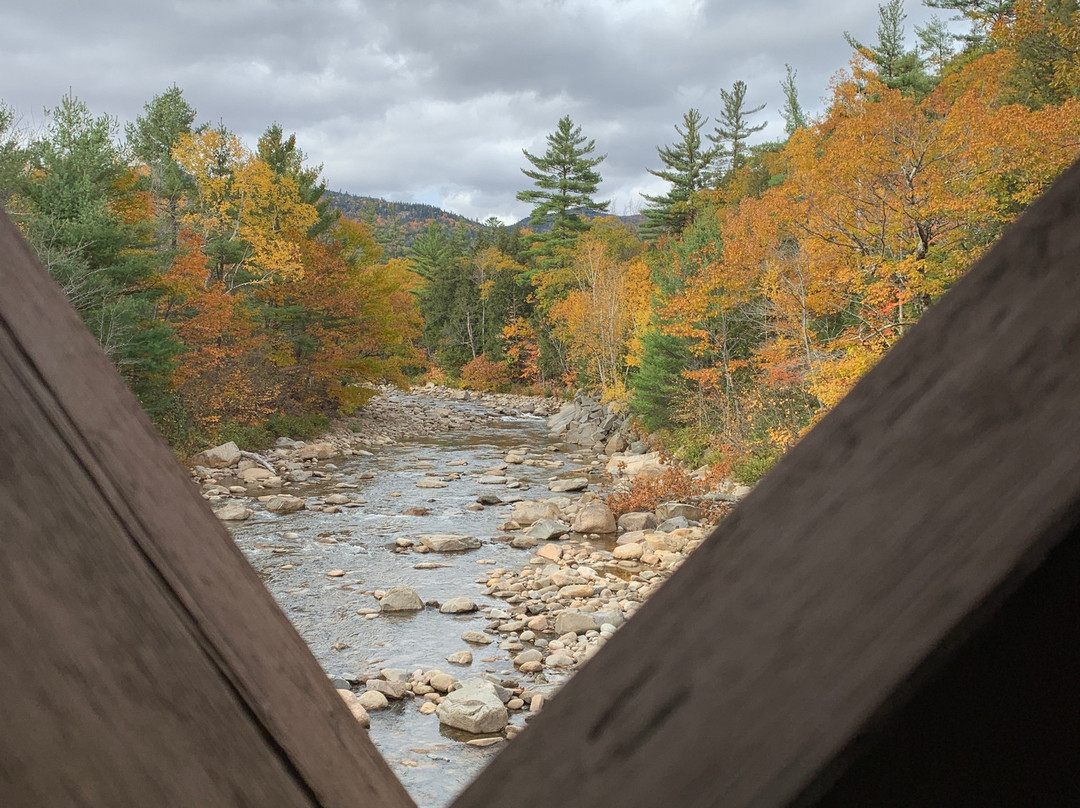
[642,109,716,239]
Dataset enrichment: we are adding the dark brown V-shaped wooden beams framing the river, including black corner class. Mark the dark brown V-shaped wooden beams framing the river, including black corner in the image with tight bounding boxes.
[0,157,1080,808]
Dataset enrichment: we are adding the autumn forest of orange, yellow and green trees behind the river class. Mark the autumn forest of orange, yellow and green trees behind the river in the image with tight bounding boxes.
[0,0,1080,482]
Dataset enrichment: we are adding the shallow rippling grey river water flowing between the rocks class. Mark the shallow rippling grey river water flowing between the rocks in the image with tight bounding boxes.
[230,404,600,808]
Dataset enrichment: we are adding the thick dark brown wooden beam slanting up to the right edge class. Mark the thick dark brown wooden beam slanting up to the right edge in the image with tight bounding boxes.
[454,159,1080,808]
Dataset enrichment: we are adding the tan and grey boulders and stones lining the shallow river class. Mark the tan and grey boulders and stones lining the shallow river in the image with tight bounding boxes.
[192,388,742,765]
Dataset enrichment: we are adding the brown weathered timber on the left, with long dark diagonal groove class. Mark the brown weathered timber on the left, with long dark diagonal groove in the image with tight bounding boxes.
[0,212,413,808]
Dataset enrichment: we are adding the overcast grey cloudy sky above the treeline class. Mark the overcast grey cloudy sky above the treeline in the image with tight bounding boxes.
[0,0,963,223]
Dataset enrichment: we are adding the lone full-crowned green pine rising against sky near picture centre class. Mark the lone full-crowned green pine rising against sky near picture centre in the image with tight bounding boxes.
[517,116,610,262]
